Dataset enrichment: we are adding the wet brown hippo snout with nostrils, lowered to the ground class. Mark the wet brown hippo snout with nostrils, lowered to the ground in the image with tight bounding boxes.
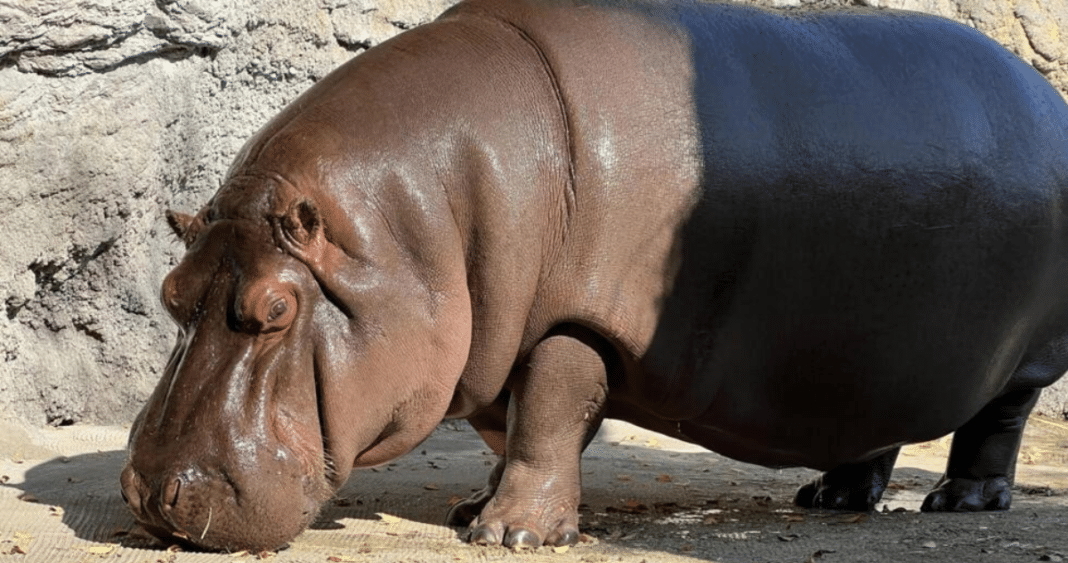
[121,464,318,551]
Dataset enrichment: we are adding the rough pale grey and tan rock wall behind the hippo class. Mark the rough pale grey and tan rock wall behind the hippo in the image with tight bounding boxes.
[0,0,1068,424]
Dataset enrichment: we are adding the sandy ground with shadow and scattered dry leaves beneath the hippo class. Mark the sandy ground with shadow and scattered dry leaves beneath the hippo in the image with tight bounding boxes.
[0,418,1068,563]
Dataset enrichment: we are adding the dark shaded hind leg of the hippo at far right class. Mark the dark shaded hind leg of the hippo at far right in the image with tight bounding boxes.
[921,338,1068,512]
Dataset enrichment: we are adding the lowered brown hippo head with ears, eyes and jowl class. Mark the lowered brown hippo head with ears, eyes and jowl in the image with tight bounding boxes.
[121,182,470,550]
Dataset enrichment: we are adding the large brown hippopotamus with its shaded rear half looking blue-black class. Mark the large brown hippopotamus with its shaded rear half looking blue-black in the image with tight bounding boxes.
[121,0,1068,550]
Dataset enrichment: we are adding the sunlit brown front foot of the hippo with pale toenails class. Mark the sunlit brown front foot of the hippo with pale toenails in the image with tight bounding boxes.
[446,462,579,549]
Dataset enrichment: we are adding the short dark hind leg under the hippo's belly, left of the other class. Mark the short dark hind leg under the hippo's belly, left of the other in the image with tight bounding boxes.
[794,448,900,512]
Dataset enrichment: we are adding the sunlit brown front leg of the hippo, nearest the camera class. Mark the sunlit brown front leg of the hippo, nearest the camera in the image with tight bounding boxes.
[457,333,607,548]
